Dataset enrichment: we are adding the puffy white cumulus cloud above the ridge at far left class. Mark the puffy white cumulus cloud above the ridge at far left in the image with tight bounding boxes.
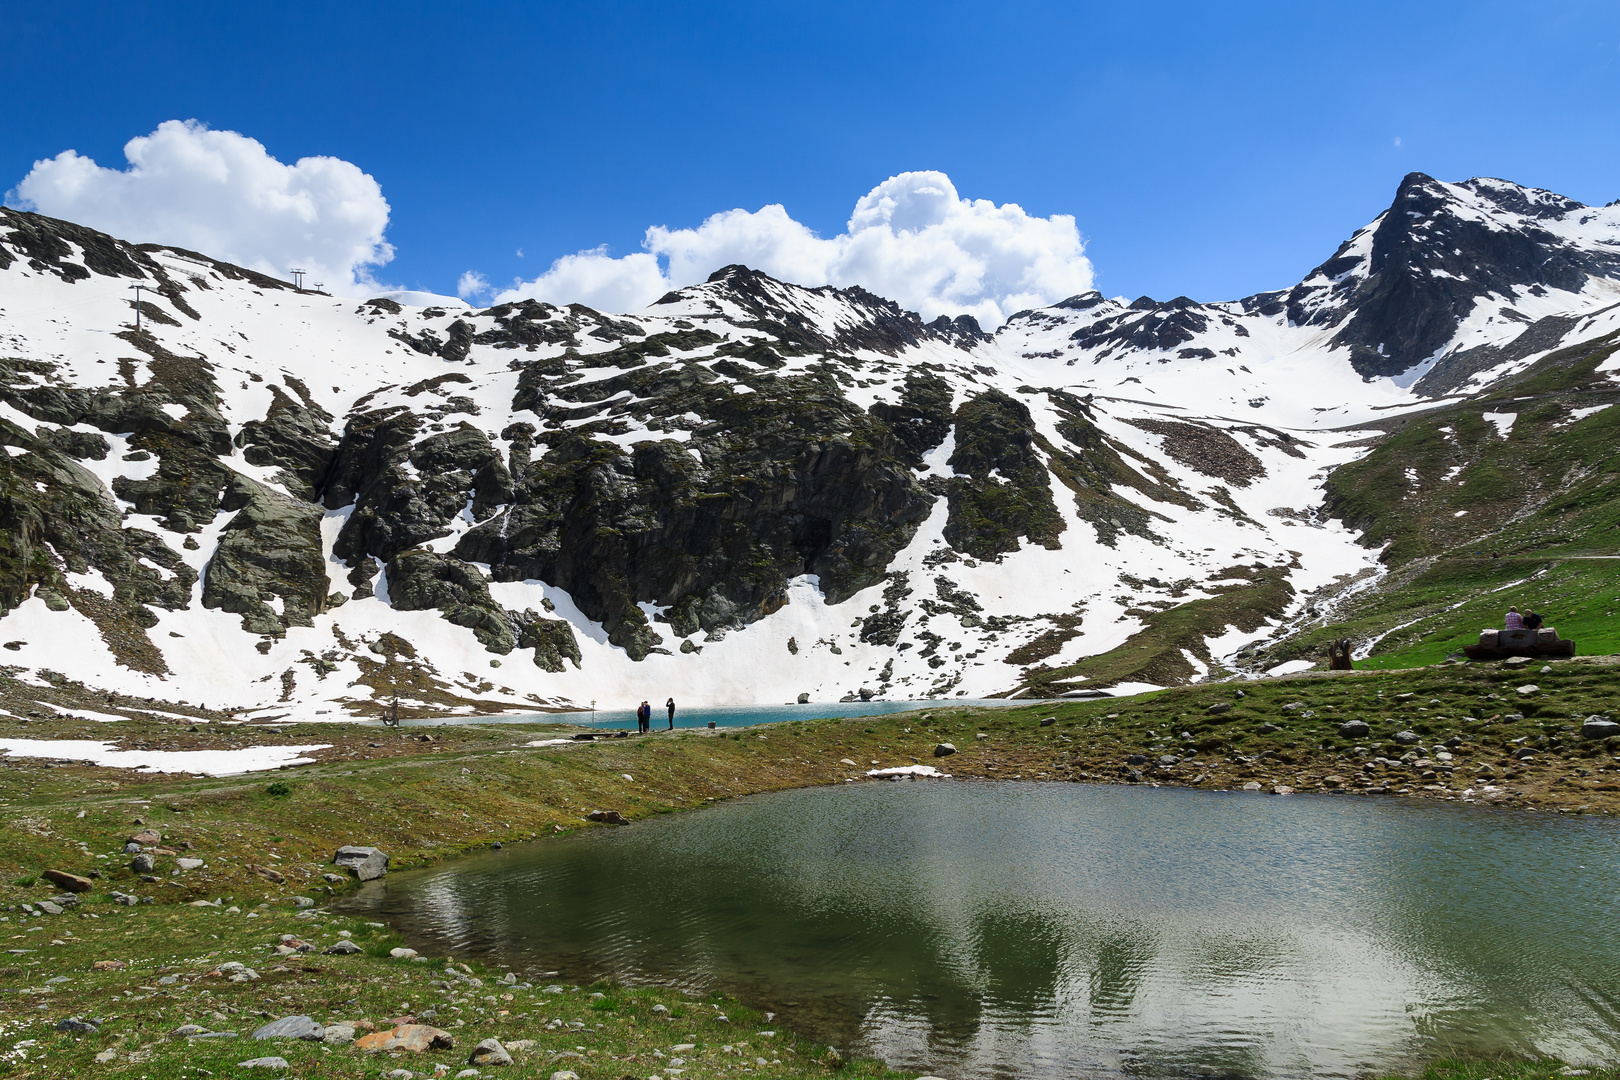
[13,120,394,293]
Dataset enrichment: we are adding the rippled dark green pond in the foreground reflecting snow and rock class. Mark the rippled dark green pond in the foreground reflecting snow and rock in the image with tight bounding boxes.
[348,782,1620,1078]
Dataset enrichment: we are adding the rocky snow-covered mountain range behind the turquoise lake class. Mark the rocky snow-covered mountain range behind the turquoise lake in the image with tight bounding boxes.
[0,173,1620,716]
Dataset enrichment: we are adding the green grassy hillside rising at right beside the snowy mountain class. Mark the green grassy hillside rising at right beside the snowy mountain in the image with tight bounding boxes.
[1024,335,1620,696]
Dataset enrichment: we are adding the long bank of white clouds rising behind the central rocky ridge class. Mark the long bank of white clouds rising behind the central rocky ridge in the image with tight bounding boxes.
[462,172,1092,329]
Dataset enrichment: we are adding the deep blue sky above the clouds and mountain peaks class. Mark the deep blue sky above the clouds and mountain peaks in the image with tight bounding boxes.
[0,0,1620,312]
